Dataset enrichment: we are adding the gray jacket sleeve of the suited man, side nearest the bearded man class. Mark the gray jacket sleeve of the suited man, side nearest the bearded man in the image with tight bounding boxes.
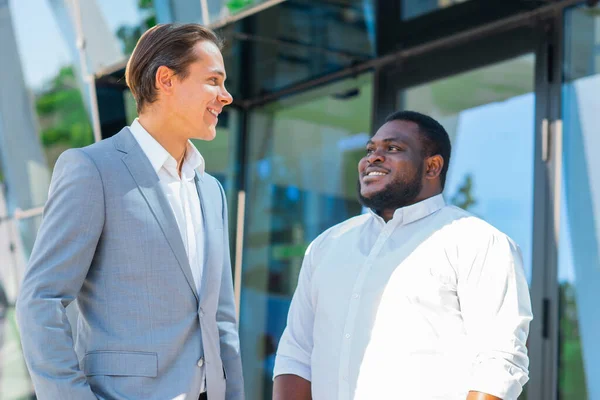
[217,181,244,400]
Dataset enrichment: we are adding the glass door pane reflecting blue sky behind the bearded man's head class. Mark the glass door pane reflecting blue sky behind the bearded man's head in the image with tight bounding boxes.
[398,54,535,399]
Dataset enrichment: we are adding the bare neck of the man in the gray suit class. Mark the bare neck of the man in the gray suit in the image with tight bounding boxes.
[138,113,188,167]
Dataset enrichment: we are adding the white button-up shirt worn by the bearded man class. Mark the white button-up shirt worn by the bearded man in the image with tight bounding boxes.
[274,195,532,400]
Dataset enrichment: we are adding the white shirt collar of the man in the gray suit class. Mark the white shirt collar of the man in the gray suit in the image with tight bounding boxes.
[129,118,205,179]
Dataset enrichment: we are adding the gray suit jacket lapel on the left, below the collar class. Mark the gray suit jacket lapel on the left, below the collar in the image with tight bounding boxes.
[116,130,199,299]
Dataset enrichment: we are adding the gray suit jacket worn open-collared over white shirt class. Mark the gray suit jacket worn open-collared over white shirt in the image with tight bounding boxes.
[17,128,244,400]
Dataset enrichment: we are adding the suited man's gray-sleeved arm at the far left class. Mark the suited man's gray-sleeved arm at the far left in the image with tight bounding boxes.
[16,149,105,400]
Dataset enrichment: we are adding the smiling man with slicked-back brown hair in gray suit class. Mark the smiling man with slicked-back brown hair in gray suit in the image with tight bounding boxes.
[17,24,244,400]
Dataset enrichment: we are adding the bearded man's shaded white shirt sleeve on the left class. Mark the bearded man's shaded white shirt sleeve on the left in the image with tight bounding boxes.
[273,244,314,381]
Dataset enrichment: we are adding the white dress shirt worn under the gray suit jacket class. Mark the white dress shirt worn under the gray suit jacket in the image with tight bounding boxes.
[129,118,205,392]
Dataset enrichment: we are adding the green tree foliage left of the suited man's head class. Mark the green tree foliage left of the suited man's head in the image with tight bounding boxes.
[36,66,93,148]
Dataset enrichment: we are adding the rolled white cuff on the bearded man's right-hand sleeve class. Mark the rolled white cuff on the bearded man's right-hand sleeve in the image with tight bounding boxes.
[469,359,529,400]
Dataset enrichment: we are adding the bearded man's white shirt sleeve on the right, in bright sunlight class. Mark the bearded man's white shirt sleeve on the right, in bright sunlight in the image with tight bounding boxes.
[458,235,533,400]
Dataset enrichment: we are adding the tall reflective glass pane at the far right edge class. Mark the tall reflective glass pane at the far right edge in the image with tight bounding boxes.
[558,7,600,400]
